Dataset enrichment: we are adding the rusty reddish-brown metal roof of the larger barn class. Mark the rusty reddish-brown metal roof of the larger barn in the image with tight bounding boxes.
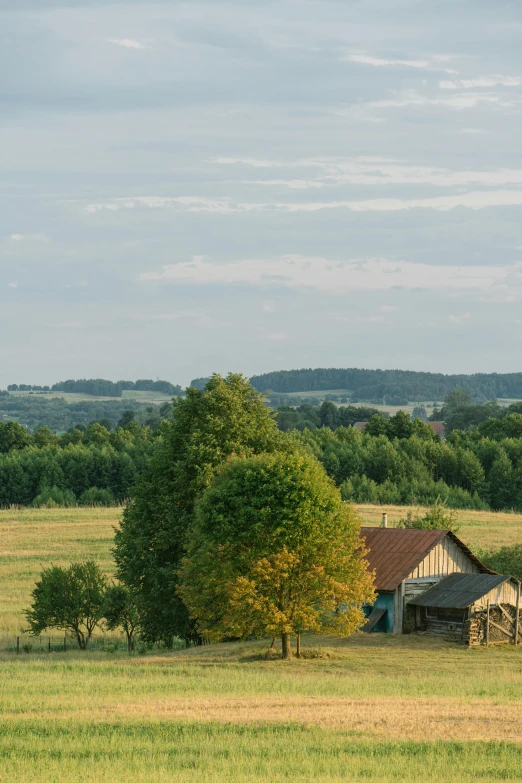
[361,527,494,591]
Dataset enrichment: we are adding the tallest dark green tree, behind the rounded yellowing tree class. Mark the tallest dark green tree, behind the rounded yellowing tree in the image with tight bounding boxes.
[114,374,284,644]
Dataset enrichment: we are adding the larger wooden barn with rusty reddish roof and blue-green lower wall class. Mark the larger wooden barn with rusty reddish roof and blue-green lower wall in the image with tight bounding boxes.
[361,527,494,633]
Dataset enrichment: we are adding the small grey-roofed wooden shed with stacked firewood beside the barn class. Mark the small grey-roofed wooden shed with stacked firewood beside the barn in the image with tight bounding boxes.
[410,573,520,643]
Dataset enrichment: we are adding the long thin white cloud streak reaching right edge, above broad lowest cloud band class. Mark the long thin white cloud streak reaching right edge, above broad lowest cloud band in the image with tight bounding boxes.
[85,190,522,215]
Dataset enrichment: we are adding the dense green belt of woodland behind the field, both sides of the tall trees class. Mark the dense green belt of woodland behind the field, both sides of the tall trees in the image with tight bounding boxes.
[5,392,522,510]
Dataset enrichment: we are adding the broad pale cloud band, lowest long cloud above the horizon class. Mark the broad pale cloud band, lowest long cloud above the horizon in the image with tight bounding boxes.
[140,256,522,293]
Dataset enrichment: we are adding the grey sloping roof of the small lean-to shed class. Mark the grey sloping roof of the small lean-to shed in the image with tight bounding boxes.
[409,574,516,609]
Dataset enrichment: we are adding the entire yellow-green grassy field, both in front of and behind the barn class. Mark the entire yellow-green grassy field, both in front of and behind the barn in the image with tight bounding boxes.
[0,506,522,783]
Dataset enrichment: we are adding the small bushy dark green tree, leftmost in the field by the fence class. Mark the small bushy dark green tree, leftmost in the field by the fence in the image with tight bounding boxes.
[25,560,107,650]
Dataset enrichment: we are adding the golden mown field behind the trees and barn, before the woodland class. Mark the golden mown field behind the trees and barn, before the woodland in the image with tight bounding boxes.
[0,506,522,647]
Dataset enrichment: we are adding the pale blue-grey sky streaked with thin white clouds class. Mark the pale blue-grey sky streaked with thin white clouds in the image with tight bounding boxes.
[0,0,522,388]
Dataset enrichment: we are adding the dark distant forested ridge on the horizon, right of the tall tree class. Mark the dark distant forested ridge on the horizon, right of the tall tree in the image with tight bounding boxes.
[250,369,522,405]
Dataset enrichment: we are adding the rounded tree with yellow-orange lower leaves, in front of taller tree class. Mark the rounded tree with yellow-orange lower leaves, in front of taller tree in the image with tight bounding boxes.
[178,453,374,659]
